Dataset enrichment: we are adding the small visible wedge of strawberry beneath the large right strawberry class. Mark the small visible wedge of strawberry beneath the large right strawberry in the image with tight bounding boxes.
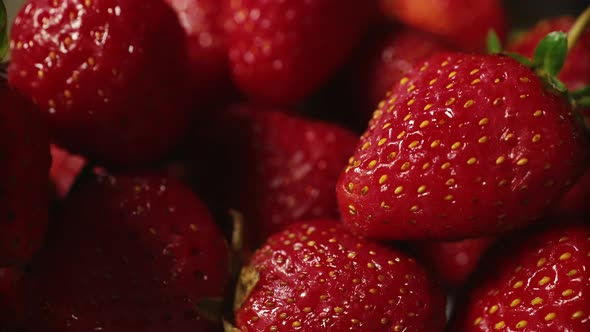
[416,238,494,288]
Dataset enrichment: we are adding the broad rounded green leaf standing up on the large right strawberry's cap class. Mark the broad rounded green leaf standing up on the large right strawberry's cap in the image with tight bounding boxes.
[533,31,567,76]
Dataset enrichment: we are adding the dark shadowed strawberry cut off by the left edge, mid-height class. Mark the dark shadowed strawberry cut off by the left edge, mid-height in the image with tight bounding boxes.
[0,79,51,266]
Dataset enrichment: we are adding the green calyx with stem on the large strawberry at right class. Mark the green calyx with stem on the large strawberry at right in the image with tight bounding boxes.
[487,7,590,113]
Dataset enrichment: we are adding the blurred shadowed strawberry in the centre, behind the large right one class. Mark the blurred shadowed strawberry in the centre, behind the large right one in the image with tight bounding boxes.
[195,106,358,242]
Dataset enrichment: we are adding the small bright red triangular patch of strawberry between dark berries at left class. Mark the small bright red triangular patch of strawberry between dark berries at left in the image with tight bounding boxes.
[49,145,86,198]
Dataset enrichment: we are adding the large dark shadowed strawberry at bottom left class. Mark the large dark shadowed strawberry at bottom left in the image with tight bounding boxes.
[28,175,228,332]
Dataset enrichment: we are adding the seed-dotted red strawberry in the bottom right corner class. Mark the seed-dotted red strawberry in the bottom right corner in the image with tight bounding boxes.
[453,225,590,332]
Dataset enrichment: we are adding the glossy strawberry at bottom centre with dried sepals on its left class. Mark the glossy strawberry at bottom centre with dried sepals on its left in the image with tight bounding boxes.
[235,220,445,332]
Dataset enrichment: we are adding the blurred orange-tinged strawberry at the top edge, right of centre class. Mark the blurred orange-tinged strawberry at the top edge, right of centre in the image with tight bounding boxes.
[379,0,508,51]
